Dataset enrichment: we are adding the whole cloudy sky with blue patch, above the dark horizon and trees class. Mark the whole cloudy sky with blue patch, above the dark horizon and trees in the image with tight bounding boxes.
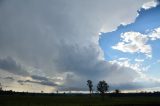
[0,0,160,92]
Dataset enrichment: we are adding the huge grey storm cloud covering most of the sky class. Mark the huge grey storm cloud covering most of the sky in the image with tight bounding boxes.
[0,0,155,92]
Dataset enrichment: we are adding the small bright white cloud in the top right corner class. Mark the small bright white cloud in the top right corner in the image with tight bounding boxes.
[142,0,159,10]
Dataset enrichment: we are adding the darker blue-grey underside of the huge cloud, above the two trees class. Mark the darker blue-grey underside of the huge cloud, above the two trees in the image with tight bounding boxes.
[53,45,139,87]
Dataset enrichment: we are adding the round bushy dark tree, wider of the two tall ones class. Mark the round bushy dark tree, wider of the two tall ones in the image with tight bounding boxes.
[97,80,109,100]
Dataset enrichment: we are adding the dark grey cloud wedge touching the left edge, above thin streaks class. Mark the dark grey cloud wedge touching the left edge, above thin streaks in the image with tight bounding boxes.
[0,57,29,76]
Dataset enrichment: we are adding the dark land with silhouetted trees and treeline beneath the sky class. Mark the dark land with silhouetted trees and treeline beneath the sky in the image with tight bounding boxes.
[0,80,160,106]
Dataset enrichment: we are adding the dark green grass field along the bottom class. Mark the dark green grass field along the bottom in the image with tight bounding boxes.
[0,95,160,106]
